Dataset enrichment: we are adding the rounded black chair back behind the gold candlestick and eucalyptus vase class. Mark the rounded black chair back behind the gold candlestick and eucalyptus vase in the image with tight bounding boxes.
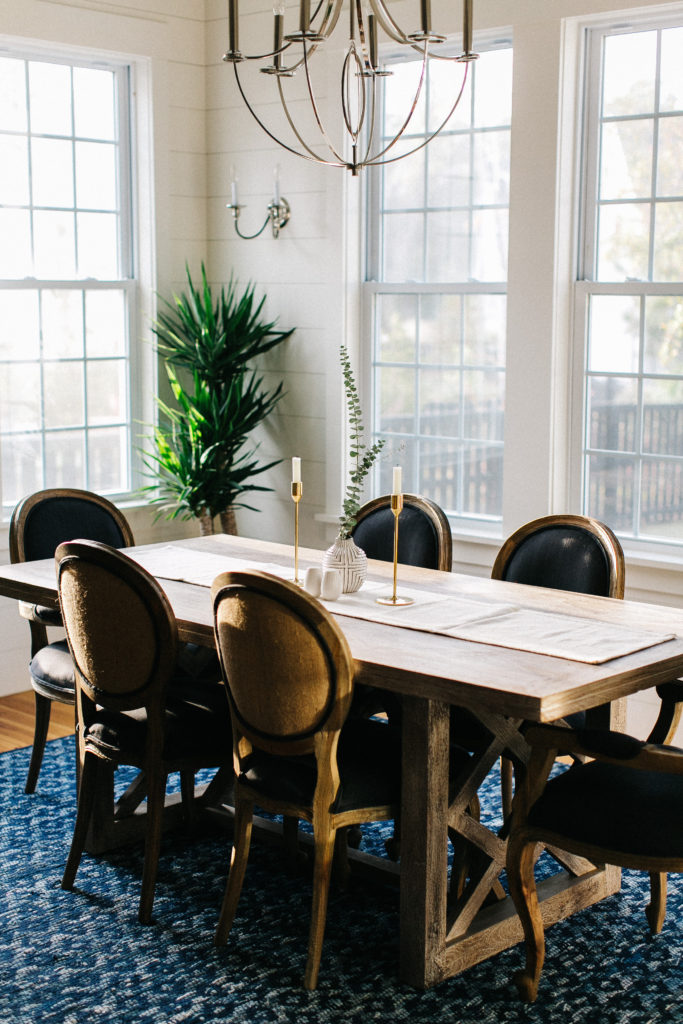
[352,495,453,572]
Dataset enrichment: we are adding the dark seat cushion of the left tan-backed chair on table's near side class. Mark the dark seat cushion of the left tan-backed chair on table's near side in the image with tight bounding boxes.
[85,683,232,767]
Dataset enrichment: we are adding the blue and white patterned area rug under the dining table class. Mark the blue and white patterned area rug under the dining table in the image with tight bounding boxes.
[0,738,683,1024]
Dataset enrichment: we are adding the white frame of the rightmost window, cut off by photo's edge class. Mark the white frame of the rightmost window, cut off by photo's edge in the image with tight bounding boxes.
[568,5,683,561]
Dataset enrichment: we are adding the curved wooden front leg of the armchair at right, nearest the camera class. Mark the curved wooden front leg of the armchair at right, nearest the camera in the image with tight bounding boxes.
[506,838,546,1002]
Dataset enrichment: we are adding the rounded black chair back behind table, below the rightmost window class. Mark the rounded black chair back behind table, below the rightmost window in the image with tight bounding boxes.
[492,515,625,597]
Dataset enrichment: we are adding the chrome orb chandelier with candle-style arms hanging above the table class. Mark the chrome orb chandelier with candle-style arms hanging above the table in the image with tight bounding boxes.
[223,0,477,175]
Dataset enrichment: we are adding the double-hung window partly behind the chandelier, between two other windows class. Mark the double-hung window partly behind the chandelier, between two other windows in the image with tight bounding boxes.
[365,41,512,529]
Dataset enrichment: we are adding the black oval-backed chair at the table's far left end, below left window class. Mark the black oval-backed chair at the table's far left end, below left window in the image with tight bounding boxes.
[9,487,134,793]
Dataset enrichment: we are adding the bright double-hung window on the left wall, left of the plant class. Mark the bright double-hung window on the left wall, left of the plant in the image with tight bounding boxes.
[0,49,135,517]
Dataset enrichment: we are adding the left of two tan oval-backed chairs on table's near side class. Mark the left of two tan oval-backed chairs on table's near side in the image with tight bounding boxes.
[55,541,231,924]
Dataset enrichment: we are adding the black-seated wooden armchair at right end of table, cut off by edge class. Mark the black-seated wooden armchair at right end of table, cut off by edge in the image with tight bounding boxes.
[506,682,683,1002]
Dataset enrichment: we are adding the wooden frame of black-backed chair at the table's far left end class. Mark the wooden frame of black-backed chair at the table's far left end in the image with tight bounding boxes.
[9,487,135,793]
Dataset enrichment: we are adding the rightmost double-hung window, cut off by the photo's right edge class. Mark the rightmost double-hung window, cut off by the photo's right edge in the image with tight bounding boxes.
[574,16,683,545]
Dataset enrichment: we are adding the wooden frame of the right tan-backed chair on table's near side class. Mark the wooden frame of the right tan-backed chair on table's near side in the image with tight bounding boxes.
[211,571,396,989]
